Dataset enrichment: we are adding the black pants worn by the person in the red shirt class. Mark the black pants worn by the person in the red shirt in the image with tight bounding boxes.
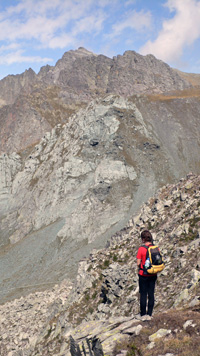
[139,275,157,316]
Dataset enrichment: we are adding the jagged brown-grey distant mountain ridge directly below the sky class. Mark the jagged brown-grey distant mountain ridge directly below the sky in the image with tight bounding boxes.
[0,47,192,152]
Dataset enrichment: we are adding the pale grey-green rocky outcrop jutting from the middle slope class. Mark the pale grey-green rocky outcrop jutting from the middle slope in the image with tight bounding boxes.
[2,97,141,243]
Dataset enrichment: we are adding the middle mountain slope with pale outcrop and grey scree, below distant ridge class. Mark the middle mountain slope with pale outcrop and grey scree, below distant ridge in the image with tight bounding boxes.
[0,88,200,304]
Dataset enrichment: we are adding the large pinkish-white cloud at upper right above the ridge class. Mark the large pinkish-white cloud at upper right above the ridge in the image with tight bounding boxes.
[140,0,200,62]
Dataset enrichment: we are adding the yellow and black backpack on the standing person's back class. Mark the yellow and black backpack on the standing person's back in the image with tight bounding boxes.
[143,245,165,274]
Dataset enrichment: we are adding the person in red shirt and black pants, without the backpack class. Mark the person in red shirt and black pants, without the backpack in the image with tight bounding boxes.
[137,230,157,319]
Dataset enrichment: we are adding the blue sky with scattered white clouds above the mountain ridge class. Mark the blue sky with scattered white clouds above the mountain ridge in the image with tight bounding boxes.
[0,0,200,79]
